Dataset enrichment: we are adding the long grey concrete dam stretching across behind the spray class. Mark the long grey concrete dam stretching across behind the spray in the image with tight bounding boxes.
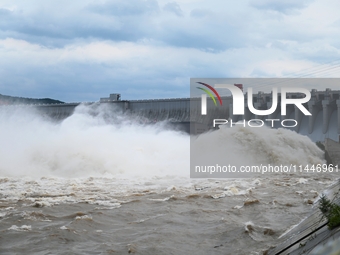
[0,89,340,141]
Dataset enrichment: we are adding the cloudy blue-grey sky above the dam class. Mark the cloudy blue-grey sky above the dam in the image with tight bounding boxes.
[0,0,340,102]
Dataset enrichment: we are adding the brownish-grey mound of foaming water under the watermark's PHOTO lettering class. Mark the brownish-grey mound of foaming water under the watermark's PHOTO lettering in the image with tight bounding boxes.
[191,126,325,169]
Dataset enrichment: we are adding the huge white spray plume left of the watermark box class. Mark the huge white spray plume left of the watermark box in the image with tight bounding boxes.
[0,106,189,177]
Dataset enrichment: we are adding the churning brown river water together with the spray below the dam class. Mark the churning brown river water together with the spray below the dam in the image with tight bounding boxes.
[0,106,336,254]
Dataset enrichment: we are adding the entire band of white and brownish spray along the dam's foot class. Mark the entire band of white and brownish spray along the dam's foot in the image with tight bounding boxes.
[0,105,323,178]
